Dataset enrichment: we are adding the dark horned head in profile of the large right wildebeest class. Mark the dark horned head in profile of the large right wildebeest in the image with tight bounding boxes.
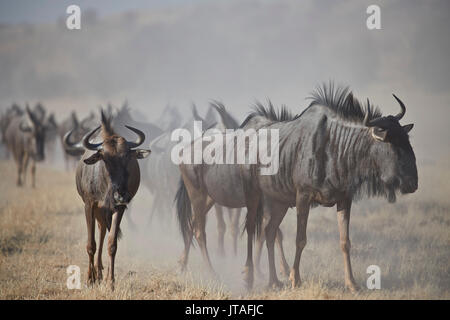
[364,95,418,201]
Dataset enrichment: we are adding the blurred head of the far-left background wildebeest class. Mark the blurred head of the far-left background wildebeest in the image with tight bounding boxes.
[19,106,47,161]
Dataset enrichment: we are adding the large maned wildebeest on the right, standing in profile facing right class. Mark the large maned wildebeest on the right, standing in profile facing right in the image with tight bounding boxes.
[243,84,418,291]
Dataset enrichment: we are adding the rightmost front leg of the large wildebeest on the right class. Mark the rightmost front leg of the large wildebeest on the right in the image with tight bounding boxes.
[337,200,357,292]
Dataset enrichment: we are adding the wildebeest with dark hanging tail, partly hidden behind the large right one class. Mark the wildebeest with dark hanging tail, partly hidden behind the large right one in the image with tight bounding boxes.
[175,101,292,288]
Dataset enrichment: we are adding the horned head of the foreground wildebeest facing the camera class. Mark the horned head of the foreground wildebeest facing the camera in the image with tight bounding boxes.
[83,112,150,206]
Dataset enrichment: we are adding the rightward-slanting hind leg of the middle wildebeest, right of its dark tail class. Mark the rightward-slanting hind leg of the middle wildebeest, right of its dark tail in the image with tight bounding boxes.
[191,195,215,275]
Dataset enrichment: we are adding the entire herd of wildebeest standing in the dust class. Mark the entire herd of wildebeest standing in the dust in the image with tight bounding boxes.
[0,83,418,291]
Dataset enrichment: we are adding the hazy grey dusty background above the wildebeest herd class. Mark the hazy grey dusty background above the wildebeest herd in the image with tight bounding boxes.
[0,0,450,162]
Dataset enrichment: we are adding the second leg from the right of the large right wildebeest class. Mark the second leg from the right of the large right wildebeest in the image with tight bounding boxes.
[289,194,309,288]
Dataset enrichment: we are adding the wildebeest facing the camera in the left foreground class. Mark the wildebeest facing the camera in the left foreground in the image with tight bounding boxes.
[64,112,150,289]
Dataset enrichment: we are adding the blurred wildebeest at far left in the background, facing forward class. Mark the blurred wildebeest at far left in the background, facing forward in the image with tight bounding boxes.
[5,106,47,187]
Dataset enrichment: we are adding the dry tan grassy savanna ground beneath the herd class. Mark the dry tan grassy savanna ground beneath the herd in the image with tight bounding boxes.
[0,158,450,299]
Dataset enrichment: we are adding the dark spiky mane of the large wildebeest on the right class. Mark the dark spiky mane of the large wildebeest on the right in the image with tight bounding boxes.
[305,81,382,123]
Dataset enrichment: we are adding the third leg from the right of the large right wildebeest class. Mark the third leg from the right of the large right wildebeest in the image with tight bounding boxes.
[264,200,288,287]
